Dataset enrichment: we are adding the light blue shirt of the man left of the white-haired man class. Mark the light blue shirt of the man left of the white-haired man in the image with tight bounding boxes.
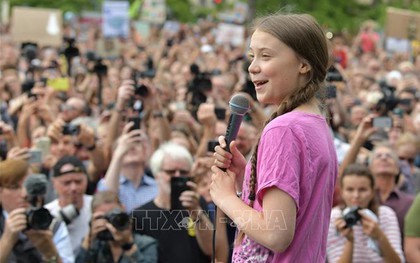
[97,174,158,213]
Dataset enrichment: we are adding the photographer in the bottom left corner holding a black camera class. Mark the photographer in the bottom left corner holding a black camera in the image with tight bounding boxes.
[0,160,74,263]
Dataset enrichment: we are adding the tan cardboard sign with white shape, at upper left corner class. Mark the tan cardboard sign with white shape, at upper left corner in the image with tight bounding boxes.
[11,6,63,46]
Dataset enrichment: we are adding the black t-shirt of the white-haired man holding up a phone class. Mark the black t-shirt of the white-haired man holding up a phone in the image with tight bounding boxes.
[133,199,211,263]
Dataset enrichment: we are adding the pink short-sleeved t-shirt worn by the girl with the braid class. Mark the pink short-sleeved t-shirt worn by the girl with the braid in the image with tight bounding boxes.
[232,111,338,263]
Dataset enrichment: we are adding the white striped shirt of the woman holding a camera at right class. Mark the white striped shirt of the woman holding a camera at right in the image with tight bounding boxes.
[327,206,404,263]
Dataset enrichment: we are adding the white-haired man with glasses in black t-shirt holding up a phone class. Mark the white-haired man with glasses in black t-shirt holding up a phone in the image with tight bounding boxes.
[133,142,213,263]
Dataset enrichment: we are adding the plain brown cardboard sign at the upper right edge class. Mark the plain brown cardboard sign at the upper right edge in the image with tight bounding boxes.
[385,7,420,40]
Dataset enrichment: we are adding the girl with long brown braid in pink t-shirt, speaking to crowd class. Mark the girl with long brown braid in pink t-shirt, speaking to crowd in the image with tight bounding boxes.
[210,14,337,263]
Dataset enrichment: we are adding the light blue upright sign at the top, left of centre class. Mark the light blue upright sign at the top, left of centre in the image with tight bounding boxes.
[102,1,130,38]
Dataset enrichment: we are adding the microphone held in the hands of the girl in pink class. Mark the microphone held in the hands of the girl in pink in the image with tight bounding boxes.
[225,94,249,152]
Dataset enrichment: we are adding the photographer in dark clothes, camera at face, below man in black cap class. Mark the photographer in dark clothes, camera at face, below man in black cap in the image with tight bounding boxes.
[76,191,157,263]
